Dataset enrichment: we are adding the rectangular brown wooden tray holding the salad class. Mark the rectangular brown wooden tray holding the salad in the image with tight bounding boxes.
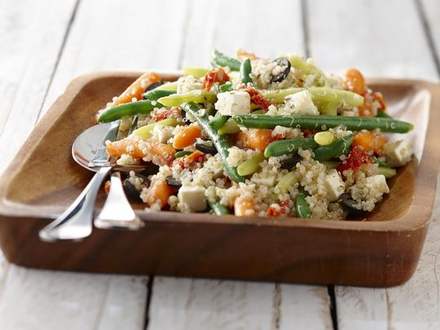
[0,72,440,286]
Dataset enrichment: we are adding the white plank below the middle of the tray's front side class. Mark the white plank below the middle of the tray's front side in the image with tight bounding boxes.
[148,277,273,330]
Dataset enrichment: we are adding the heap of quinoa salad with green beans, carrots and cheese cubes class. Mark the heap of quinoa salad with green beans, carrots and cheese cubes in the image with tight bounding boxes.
[97,50,413,220]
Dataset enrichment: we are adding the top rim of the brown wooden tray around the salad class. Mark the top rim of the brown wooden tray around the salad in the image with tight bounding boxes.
[0,70,440,232]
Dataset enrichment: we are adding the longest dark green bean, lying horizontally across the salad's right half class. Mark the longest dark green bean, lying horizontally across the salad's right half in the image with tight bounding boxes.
[232,114,413,133]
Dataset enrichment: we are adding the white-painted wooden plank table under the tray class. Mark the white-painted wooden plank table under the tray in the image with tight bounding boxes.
[0,0,440,330]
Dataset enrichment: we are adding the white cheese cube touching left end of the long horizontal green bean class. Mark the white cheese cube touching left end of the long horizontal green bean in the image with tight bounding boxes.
[215,91,251,116]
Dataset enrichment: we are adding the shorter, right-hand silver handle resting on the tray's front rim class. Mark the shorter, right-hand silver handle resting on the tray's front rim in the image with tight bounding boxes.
[95,172,143,230]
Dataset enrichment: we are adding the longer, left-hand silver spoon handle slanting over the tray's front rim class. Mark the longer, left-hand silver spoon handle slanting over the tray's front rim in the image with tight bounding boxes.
[39,166,111,242]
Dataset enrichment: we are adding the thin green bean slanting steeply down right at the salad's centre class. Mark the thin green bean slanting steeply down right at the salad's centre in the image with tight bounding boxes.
[182,103,245,182]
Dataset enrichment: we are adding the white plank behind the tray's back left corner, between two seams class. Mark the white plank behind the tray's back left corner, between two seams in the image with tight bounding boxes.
[43,0,189,112]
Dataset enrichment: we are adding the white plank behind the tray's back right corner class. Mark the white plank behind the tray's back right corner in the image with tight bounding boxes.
[308,0,437,79]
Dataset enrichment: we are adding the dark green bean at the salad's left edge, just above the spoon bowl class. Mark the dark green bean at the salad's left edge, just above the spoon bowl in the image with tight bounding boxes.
[98,100,162,123]
